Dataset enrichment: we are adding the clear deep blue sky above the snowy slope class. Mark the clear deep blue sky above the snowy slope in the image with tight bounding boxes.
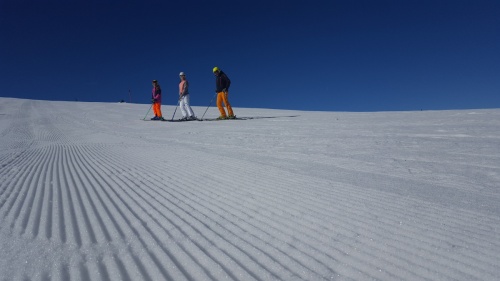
[0,0,500,111]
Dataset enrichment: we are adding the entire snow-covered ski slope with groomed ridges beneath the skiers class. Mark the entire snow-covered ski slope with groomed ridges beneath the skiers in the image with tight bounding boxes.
[0,98,500,280]
